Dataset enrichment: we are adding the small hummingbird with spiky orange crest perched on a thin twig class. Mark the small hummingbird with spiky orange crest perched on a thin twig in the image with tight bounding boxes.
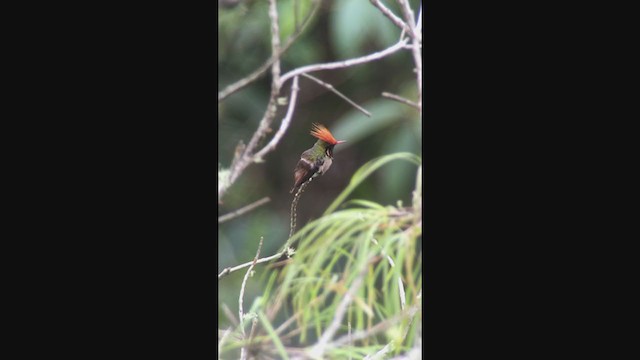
[289,123,345,194]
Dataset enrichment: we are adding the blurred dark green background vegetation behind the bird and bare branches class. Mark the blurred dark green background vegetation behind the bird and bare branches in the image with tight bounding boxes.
[218,0,422,323]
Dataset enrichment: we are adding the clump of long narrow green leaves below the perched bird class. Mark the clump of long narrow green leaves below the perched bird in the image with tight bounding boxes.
[219,153,422,359]
